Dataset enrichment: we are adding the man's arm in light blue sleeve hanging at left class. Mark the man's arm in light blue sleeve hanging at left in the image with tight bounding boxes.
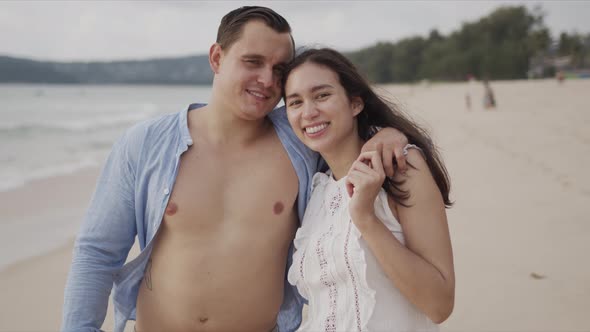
[61,131,136,331]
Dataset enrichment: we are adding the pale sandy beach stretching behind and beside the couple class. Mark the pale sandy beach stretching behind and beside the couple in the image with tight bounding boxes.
[0,80,590,332]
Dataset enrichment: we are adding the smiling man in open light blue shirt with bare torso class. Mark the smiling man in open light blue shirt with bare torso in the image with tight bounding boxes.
[62,7,406,331]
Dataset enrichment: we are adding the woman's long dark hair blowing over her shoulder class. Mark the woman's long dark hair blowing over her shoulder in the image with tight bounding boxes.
[282,48,453,207]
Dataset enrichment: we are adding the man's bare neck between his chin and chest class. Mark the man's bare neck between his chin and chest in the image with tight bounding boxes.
[188,102,272,146]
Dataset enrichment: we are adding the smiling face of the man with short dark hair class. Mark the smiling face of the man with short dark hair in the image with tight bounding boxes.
[216,21,293,120]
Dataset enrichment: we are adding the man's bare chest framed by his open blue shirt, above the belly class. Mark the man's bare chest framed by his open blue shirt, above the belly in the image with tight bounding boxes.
[164,144,298,229]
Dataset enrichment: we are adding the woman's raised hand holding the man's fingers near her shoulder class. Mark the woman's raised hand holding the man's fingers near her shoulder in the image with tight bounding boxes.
[345,145,385,229]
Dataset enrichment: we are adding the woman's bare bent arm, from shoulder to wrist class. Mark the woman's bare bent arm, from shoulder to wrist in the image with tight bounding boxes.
[351,149,455,323]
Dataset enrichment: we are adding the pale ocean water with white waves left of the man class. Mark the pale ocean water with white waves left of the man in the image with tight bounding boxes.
[0,85,211,191]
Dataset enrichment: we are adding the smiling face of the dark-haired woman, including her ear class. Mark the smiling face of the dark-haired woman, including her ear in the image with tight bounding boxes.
[285,62,363,153]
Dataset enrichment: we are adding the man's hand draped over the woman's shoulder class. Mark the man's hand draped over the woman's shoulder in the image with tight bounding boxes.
[361,127,408,177]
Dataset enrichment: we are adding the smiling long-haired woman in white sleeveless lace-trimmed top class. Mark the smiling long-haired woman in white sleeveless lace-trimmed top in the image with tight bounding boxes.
[283,49,455,331]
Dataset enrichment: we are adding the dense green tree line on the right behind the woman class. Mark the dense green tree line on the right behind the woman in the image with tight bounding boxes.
[347,6,590,83]
